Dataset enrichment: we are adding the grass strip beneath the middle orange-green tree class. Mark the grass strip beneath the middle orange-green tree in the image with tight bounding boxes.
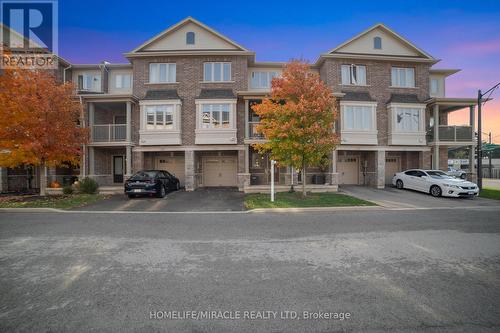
[245,192,375,209]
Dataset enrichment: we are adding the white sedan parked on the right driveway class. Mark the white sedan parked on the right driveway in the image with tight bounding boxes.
[392,169,479,198]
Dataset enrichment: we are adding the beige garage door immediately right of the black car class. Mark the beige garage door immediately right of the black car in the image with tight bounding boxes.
[203,156,236,186]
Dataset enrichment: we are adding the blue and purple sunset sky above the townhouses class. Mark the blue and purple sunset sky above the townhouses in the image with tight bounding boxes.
[59,0,500,143]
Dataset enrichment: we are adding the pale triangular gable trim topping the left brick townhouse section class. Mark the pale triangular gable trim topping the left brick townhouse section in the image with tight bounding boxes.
[128,16,249,54]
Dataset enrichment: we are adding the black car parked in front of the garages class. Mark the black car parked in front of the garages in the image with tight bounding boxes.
[124,170,180,198]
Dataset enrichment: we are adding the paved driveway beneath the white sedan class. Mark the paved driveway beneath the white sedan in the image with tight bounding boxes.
[340,185,500,208]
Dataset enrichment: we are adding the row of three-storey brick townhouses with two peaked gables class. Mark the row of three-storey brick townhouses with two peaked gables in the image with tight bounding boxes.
[0,18,475,192]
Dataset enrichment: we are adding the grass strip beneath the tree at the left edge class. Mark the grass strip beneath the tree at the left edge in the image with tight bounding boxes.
[0,194,105,209]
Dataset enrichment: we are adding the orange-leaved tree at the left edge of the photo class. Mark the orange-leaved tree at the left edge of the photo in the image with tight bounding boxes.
[0,70,88,195]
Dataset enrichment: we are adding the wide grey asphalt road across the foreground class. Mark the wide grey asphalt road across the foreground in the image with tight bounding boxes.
[0,207,500,332]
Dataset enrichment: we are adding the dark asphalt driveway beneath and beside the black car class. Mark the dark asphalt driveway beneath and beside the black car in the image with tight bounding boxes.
[75,188,244,212]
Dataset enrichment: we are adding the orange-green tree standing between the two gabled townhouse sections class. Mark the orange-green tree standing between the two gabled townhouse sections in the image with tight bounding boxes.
[253,61,338,196]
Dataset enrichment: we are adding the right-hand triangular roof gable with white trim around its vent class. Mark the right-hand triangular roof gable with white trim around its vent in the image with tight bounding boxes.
[324,23,438,62]
